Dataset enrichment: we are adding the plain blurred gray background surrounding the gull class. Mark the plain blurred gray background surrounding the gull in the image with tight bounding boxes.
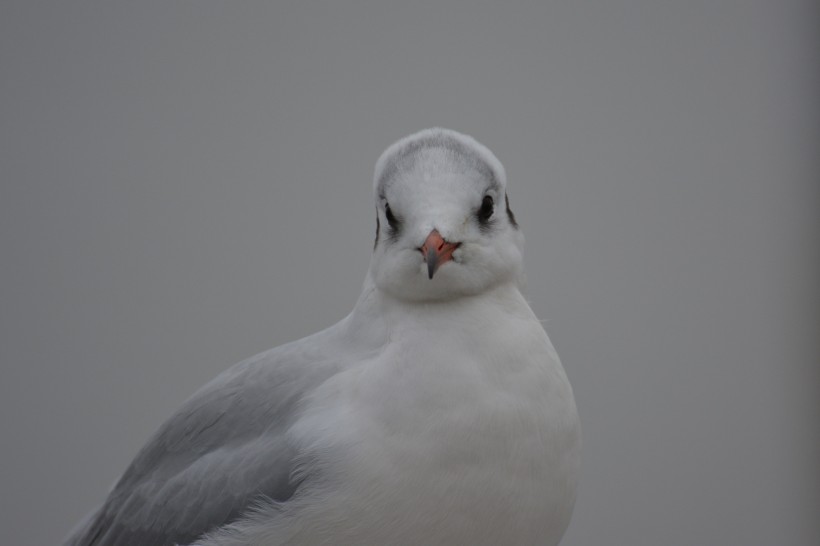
[0,0,820,546]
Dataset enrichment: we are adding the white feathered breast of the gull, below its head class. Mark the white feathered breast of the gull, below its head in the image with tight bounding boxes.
[284,284,579,545]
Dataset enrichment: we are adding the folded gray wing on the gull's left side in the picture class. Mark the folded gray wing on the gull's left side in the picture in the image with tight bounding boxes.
[66,340,338,546]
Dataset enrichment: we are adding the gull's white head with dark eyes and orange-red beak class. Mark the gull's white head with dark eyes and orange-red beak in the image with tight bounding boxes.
[370,128,524,301]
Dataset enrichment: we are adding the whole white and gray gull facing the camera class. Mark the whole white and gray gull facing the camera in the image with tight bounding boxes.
[65,128,580,546]
